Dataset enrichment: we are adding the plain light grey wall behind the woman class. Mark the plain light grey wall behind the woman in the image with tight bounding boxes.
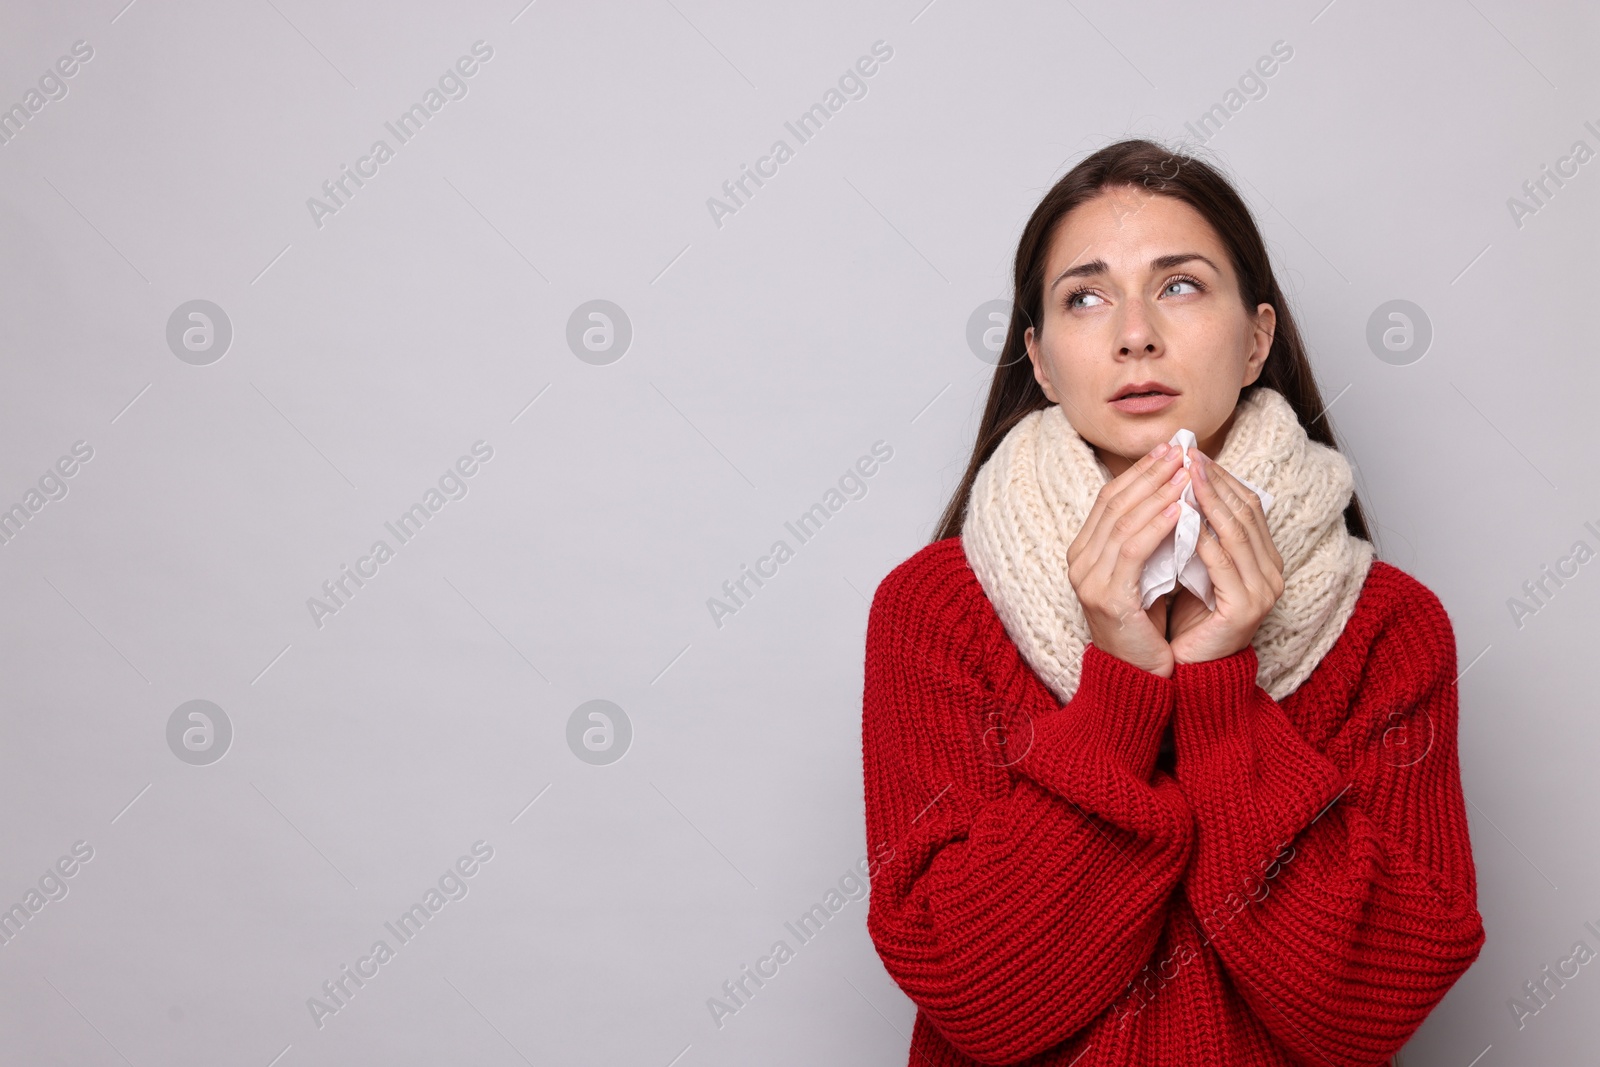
[0,0,1600,1067]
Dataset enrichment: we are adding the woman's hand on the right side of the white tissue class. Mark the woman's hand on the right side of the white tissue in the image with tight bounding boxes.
[1168,450,1283,664]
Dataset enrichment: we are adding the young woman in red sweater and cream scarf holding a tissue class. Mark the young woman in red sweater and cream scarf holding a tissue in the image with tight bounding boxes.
[862,141,1485,1067]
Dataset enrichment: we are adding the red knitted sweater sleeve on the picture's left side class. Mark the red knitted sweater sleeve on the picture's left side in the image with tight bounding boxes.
[862,575,1194,1064]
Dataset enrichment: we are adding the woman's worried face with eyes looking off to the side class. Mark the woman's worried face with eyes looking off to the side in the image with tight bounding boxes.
[1024,186,1277,477]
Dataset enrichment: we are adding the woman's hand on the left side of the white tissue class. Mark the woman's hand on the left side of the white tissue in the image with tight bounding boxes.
[1067,443,1189,678]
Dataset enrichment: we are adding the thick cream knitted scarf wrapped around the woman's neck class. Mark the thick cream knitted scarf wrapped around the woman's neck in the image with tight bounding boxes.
[962,387,1373,702]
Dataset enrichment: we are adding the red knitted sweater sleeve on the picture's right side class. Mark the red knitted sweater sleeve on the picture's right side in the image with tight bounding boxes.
[1173,584,1485,1067]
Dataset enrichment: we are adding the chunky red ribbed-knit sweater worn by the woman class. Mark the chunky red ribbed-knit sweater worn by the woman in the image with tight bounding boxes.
[861,537,1483,1067]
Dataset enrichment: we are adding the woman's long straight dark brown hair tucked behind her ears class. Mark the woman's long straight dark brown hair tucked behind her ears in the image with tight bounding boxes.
[933,139,1371,541]
